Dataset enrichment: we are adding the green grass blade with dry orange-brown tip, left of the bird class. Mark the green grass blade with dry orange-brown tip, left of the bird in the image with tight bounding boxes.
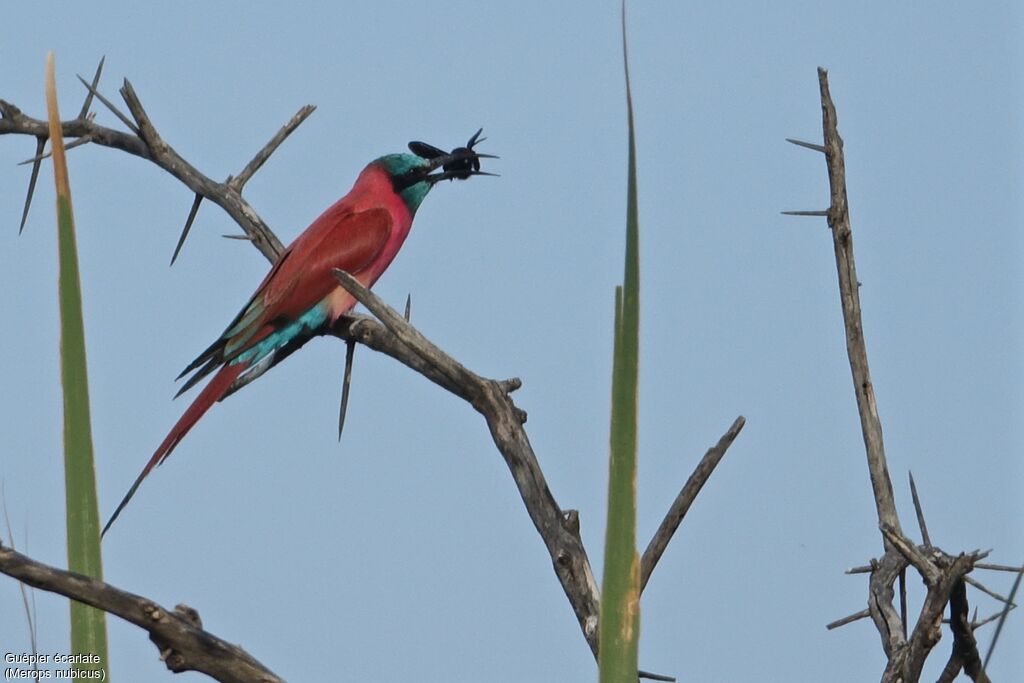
[46,52,110,680]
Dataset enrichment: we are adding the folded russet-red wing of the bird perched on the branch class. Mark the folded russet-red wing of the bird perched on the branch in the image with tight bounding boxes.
[179,203,393,393]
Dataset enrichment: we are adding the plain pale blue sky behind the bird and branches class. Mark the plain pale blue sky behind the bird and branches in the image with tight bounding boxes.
[0,2,1024,682]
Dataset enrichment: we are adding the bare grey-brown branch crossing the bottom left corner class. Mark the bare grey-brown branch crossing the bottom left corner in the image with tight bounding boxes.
[0,545,284,683]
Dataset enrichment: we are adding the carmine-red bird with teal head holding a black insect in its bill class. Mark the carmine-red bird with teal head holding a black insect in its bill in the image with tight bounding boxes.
[102,131,493,533]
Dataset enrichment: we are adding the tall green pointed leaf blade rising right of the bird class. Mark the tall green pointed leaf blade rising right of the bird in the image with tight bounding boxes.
[598,5,640,683]
